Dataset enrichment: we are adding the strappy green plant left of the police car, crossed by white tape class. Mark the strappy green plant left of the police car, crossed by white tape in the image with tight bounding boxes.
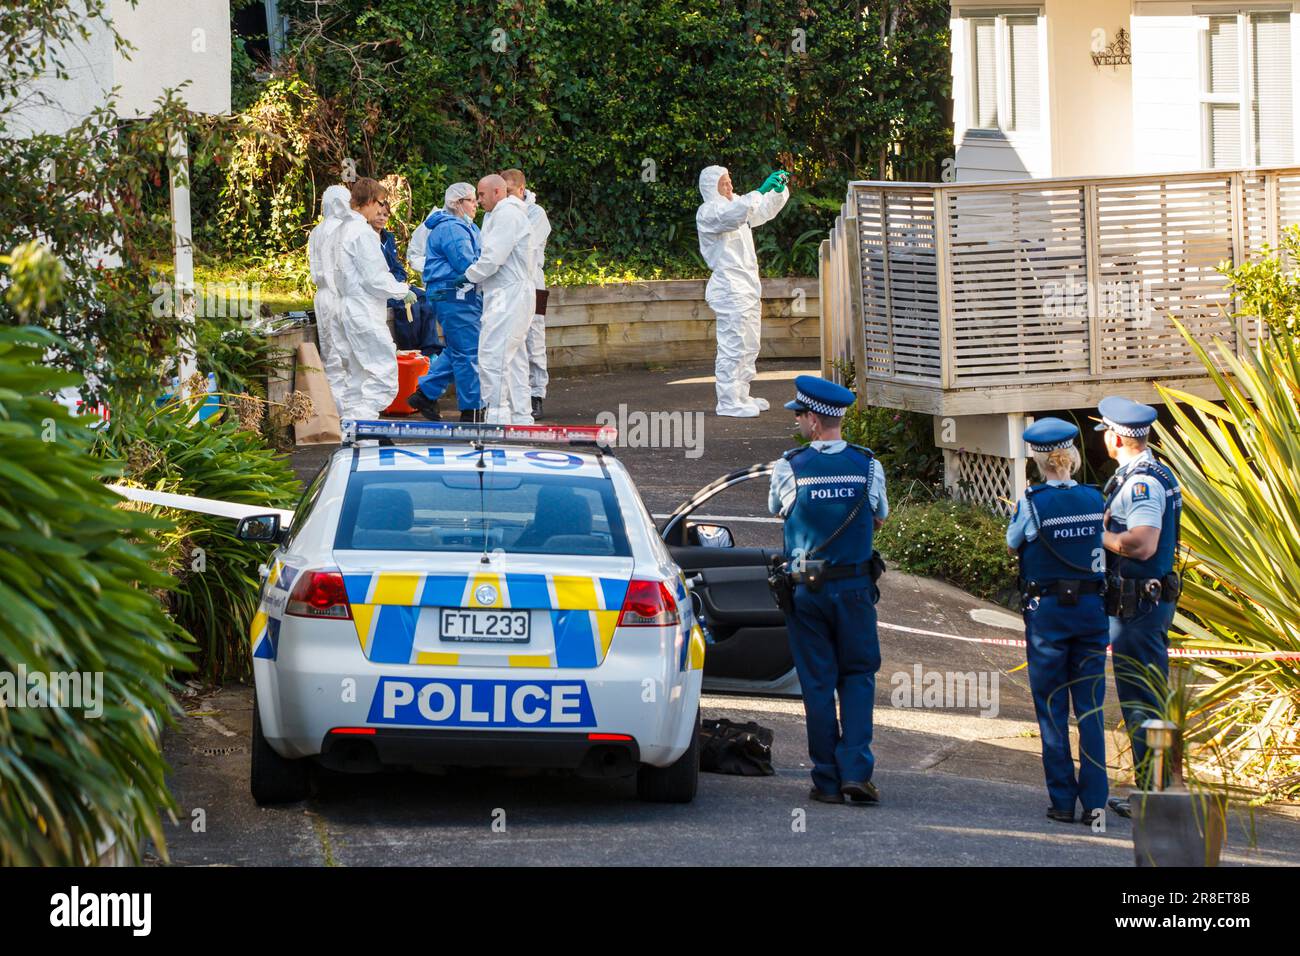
[101,402,300,680]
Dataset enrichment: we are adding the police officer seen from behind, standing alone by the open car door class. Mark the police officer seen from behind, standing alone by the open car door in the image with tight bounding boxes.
[768,375,889,804]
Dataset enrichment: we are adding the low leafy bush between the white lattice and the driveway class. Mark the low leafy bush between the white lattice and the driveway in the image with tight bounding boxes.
[876,498,1018,607]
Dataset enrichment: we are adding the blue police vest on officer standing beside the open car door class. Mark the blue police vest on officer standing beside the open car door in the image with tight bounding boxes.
[783,445,883,564]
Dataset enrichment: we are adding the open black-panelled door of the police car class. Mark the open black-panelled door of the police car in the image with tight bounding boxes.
[660,463,800,696]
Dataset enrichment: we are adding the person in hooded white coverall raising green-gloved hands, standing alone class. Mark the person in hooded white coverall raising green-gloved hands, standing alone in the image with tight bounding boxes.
[696,166,789,419]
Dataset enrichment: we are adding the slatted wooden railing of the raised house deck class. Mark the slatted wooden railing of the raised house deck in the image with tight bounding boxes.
[822,168,1300,410]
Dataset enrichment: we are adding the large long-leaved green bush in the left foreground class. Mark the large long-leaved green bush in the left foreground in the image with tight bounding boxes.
[0,326,190,865]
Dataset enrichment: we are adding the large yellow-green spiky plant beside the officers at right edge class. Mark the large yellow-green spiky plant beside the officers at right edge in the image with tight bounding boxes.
[1160,326,1300,795]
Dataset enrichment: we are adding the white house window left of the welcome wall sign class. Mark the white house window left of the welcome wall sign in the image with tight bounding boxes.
[966,13,1041,133]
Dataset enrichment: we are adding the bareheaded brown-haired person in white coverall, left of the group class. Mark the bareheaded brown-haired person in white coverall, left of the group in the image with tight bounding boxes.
[338,178,415,419]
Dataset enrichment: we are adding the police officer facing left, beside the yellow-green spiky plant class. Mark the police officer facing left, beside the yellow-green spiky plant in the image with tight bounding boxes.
[1097,395,1183,817]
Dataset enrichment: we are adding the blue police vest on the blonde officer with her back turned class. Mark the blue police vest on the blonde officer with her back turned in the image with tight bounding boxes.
[1021,485,1105,584]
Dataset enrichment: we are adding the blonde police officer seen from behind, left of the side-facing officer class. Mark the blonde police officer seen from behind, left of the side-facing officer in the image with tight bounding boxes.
[1006,418,1110,825]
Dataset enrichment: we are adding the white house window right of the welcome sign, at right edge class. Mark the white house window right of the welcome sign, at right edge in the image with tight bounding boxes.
[1201,12,1295,168]
